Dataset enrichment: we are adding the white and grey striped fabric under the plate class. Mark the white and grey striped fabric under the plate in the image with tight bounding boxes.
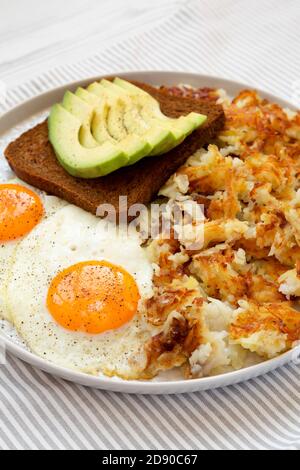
[0,0,300,450]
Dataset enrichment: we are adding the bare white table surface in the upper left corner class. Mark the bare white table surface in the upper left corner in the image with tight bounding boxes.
[0,0,186,87]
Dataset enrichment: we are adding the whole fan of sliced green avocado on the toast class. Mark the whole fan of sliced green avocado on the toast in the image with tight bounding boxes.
[48,79,206,178]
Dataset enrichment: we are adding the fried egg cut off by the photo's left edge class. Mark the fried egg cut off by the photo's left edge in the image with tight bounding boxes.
[0,178,66,321]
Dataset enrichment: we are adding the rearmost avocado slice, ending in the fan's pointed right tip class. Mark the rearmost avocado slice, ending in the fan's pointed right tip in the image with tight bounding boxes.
[114,78,207,150]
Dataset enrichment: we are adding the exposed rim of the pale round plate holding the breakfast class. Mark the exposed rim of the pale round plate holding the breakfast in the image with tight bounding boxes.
[0,72,297,394]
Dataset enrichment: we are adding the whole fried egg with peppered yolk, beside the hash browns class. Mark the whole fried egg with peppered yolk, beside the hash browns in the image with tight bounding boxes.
[6,205,153,379]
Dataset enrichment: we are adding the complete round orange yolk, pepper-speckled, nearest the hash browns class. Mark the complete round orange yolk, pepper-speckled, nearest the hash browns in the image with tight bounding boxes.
[47,261,140,335]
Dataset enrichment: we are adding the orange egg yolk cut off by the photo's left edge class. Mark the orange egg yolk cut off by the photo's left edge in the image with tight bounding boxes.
[0,184,44,243]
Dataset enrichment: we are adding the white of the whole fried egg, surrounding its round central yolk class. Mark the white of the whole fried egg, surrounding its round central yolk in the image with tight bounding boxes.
[6,205,153,379]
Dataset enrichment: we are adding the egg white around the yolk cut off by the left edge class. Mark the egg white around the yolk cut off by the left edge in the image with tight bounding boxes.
[0,178,67,321]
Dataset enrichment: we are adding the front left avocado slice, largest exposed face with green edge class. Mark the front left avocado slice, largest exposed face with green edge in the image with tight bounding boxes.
[48,104,128,178]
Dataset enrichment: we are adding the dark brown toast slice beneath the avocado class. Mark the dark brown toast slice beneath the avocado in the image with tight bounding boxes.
[4,82,225,215]
